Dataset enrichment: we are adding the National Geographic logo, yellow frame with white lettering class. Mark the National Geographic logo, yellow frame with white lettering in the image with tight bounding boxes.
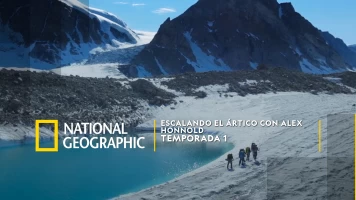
[35,119,145,152]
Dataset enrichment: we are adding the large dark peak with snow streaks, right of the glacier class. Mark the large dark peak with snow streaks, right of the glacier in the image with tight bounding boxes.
[121,0,351,77]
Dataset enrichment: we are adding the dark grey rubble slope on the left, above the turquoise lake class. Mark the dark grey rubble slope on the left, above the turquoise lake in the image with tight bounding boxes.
[0,69,174,131]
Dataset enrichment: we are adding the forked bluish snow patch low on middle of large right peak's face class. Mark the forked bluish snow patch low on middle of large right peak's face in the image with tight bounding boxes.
[181,32,231,72]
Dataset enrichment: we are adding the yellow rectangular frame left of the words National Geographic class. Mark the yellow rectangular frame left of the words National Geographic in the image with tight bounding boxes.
[35,120,58,152]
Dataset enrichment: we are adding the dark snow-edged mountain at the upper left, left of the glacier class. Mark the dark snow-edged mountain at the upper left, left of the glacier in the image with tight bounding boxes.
[0,0,140,69]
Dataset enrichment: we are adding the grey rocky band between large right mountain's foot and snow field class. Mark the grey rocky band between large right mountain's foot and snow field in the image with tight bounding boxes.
[162,68,356,98]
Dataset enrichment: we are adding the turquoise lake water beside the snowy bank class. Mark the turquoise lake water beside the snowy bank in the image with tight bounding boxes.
[0,134,233,200]
